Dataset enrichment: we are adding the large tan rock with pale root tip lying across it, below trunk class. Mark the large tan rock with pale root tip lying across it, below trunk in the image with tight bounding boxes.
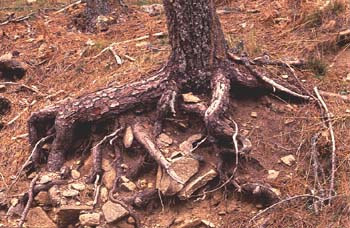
[157,157,199,196]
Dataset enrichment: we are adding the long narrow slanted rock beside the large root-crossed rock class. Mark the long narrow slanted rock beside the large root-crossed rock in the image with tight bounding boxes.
[178,169,217,200]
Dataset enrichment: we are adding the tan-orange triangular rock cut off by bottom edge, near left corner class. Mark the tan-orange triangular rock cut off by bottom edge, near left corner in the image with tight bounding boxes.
[25,207,57,228]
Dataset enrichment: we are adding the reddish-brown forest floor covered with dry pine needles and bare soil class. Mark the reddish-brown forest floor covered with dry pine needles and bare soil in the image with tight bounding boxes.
[0,0,350,228]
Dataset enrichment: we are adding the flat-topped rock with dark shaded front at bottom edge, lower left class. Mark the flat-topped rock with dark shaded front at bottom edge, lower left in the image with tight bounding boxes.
[56,206,93,227]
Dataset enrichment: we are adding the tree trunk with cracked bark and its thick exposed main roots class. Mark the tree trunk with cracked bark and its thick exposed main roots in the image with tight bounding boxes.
[28,0,261,170]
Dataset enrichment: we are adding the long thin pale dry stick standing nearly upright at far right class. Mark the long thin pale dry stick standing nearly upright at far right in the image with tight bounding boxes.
[314,87,336,197]
